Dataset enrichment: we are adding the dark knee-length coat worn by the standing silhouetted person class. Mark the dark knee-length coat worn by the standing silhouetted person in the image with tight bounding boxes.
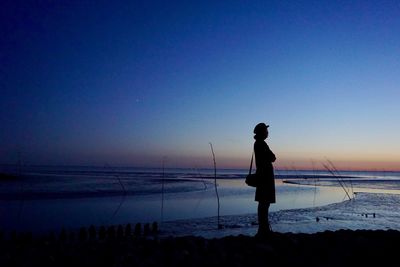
[254,140,276,203]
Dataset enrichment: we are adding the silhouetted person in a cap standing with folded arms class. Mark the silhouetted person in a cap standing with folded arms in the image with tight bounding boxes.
[254,123,276,236]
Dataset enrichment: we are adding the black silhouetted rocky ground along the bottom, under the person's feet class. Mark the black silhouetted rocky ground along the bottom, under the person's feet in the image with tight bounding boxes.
[0,228,400,267]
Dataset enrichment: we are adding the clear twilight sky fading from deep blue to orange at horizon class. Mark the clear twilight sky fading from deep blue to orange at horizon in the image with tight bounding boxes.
[0,0,400,170]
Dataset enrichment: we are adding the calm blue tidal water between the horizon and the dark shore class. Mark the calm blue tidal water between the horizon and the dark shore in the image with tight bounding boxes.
[0,166,400,236]
